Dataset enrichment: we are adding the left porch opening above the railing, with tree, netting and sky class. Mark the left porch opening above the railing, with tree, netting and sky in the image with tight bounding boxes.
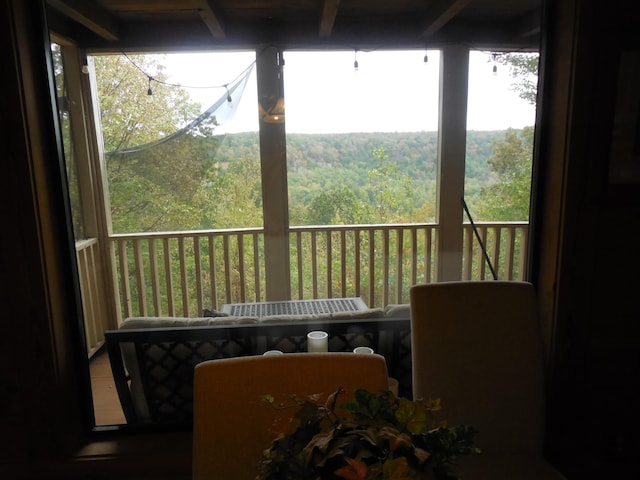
[93,52,262,233]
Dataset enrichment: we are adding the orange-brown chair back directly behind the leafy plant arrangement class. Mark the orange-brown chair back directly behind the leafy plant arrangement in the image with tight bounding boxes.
[193,353,388,480]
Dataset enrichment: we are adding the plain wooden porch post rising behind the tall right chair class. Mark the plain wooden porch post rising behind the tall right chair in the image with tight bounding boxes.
[436,45,469,282]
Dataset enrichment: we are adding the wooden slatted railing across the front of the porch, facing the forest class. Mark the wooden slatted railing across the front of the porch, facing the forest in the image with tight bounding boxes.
[100,222,528,318]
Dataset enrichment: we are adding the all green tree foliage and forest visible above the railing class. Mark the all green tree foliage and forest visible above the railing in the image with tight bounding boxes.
[94,54,537,233]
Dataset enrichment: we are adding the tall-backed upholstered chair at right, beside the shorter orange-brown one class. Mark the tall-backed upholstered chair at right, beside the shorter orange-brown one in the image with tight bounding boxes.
[411,281,563,480]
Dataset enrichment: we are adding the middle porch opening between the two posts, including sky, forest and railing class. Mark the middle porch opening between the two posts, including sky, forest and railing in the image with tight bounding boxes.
[284,49,440,306]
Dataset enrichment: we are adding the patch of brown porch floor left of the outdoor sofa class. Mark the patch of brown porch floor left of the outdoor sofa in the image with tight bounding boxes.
[89,351,126,425]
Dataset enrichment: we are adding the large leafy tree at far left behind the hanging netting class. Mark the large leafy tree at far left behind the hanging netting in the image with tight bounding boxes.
[93,55,225,233]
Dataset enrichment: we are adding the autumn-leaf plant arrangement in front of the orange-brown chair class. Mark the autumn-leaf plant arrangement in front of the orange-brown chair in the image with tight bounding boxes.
[258,389,477,480]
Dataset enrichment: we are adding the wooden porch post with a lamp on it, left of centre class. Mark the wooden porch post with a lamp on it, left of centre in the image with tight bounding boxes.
[256,47,291,301]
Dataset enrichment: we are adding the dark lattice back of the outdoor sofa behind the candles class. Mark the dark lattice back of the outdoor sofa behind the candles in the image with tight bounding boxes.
[106,319,412,426]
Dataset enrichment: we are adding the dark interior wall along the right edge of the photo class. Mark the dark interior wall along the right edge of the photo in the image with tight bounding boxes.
[535,0,640,479]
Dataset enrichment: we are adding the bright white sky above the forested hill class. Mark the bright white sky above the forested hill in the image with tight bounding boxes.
[163,50,535,133]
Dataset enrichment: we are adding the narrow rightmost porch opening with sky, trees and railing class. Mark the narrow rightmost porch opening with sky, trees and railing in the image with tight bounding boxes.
[464,51,538,279]
